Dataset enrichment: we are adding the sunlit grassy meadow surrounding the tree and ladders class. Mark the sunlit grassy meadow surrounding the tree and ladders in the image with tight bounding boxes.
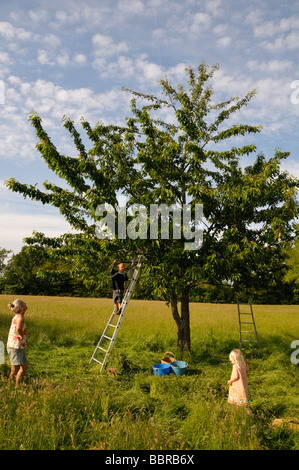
[0,295,299,450]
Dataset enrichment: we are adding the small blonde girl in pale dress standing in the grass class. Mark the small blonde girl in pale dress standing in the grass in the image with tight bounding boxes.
[227,349,249,410]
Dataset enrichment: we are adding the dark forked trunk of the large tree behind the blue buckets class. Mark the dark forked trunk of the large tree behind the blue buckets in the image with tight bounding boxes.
[170,286,191,351]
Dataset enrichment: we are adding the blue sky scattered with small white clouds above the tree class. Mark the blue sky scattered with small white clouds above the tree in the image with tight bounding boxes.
[0,0,299,253]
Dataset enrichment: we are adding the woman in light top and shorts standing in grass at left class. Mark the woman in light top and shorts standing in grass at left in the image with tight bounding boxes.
[7,299,28,386]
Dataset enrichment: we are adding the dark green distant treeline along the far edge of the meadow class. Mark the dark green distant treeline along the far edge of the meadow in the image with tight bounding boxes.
[0,247,299,304]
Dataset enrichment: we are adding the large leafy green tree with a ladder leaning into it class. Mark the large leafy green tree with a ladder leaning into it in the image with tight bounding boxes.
[6,63,298,349]
